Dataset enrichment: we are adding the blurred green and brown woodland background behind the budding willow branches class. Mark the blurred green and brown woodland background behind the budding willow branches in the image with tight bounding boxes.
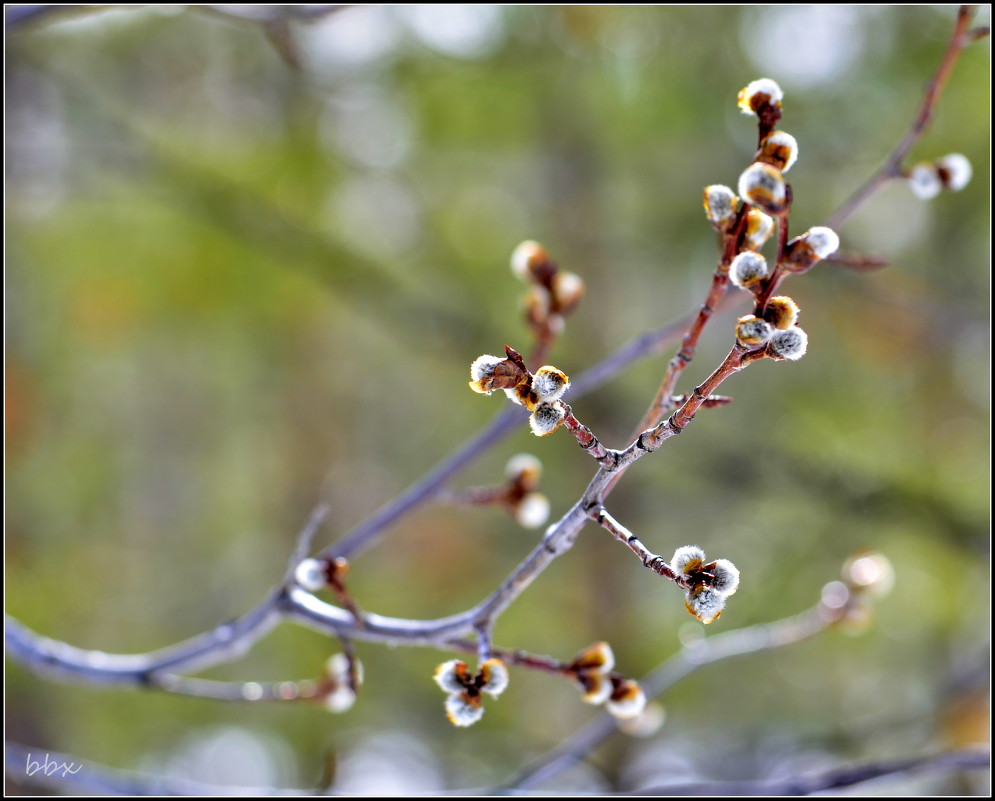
[5,6,991,794]
